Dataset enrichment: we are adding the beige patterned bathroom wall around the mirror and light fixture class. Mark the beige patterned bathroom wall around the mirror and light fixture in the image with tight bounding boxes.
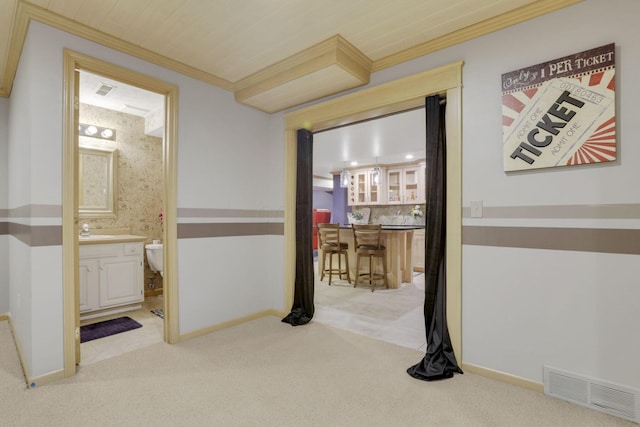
[79,104,163,291]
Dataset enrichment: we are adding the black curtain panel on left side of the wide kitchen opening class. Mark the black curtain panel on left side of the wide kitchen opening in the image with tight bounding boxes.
[282,129,314,326]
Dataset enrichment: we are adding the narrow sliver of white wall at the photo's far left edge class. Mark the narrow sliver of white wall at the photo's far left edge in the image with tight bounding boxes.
[0,98,9,313]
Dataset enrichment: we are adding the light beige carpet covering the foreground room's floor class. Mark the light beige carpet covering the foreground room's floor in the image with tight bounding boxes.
[0,316,637,427]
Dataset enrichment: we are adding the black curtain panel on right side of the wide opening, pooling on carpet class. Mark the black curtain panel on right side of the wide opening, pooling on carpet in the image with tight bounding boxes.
[407,96,462,381]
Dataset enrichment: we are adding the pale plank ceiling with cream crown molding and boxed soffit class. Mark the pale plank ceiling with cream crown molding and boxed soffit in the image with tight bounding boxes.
[0,0,580,113]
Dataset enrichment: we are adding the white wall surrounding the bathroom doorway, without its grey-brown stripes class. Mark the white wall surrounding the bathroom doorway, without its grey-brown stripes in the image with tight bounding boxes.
[9,22,284,377]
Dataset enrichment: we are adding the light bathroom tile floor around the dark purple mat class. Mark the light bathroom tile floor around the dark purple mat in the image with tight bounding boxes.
[80,295,164,366]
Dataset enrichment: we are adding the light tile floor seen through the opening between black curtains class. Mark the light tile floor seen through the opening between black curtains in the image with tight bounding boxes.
[313,263,427,351]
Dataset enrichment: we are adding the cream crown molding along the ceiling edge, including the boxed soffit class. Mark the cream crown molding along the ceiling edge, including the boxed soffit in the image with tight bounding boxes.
[0,0,582,113]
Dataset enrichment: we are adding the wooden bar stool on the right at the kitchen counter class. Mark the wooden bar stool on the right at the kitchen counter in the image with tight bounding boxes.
[351,224,389,292]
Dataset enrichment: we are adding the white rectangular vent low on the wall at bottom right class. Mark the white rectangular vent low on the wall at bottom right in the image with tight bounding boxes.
[544,366,640,422]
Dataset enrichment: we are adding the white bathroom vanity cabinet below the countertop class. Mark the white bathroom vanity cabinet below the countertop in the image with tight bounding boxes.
[79,242,144,313]
